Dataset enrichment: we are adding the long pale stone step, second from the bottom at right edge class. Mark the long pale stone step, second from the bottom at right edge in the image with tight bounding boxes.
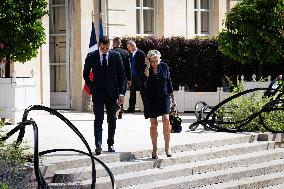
[120,159,284,189]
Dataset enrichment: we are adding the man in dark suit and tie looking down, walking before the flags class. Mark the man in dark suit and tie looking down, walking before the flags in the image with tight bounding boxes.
[83,37,125,155]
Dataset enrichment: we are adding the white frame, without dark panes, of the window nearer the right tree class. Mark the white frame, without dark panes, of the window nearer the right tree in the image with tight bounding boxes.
[194,0,213,36]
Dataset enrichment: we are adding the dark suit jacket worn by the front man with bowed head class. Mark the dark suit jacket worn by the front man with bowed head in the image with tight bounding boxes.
[83,50,125,99]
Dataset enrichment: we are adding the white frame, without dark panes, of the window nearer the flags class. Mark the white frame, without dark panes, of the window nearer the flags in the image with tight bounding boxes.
[135,0,157,36]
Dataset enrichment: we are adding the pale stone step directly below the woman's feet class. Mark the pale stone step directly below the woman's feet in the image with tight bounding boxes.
[53,142,276,182]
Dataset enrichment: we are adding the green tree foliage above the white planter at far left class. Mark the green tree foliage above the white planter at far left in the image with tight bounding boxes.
[0,0,48,63]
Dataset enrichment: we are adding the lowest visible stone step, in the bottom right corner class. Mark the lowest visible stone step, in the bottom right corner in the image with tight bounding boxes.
[195,170,284,189]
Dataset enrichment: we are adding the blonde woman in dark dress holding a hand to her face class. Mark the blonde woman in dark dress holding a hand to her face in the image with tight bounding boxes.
[144,50,176,159]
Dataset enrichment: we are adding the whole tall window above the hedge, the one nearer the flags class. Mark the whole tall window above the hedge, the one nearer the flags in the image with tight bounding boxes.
[136,0,156,35]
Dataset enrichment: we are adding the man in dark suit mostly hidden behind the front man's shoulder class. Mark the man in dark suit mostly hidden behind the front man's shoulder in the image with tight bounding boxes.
[112,37,131,119]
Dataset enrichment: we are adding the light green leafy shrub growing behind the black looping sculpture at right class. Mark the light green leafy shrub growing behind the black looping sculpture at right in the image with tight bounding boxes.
[216,79,284,132]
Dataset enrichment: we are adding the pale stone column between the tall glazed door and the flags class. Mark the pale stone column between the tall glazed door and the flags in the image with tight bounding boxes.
[70,0,94,111]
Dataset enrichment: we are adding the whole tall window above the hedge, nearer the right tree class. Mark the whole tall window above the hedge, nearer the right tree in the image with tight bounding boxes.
[194,0,211,35]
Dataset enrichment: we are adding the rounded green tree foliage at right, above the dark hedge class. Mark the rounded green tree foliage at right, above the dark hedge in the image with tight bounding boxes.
[218,0,284,63]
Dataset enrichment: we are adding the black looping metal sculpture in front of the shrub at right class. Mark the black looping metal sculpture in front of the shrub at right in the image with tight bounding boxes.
[189,83,284,133]
